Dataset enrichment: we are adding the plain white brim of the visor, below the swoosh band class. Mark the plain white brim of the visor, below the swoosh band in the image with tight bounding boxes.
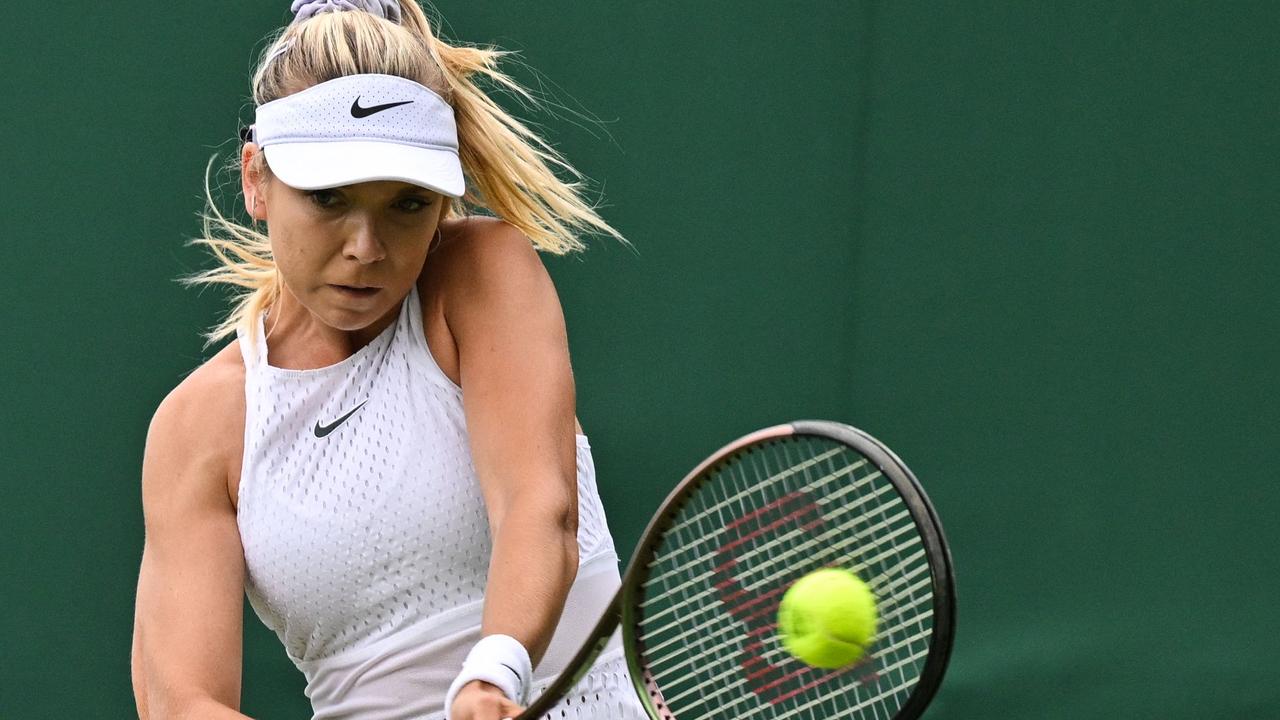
[262,140,466,197]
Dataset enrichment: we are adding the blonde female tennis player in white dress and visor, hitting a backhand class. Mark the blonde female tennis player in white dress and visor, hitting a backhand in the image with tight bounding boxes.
[132,0,645,720]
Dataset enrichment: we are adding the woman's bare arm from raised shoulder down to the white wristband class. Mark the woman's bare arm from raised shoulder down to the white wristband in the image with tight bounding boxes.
[440,218,577,717]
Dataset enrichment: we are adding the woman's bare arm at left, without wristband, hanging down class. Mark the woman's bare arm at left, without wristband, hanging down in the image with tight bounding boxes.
[132,365,246,720]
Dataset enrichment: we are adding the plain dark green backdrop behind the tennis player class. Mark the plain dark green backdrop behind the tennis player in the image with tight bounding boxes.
[0,0,1280,720]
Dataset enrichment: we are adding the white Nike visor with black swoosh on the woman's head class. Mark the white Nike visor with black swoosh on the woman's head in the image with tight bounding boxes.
[251,74,466,197]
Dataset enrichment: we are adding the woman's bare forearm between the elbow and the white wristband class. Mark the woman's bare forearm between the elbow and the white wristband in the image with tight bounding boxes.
[481,503,579,665]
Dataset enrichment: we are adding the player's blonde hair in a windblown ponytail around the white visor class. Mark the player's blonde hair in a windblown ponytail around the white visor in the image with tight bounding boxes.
[180,0,626,347]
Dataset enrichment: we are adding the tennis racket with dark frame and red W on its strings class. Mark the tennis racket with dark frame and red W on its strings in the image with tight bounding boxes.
[518,420,955,720]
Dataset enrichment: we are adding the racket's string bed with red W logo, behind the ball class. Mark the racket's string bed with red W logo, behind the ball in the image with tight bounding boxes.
[637,438,933,720]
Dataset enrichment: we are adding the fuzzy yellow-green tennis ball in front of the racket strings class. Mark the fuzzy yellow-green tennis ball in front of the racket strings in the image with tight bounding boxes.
[778,568,876,669]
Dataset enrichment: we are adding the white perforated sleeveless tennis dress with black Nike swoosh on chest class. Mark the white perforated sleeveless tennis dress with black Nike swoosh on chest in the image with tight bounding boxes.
[238,287,646,720]
